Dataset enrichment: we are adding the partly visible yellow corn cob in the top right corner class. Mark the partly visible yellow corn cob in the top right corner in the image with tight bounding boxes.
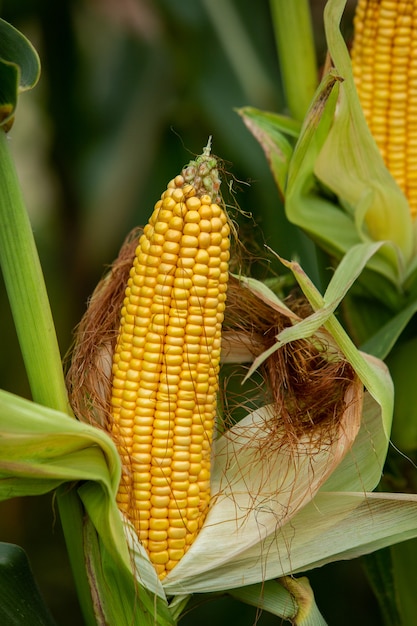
[351,0,417,218]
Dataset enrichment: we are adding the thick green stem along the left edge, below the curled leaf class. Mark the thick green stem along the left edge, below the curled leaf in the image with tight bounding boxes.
[0,131,69,413]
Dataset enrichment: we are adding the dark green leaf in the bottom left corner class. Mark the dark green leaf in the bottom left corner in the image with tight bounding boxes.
[0,543,55,626]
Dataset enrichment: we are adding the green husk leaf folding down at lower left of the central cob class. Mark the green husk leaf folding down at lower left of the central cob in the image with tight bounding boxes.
[0,390,174,626]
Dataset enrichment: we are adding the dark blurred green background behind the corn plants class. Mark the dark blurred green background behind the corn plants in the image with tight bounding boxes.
[0,0,380,626]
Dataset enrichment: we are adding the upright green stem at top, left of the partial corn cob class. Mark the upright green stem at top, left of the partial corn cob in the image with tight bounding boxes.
[270,0,318,121]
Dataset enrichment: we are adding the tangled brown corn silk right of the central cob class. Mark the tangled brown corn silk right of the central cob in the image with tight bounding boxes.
[222,277,363,454]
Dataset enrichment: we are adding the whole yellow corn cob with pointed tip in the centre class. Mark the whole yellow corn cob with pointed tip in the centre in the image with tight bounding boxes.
[111,140,229,579]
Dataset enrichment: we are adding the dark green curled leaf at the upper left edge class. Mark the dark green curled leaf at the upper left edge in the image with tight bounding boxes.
[0,20,40,130]
